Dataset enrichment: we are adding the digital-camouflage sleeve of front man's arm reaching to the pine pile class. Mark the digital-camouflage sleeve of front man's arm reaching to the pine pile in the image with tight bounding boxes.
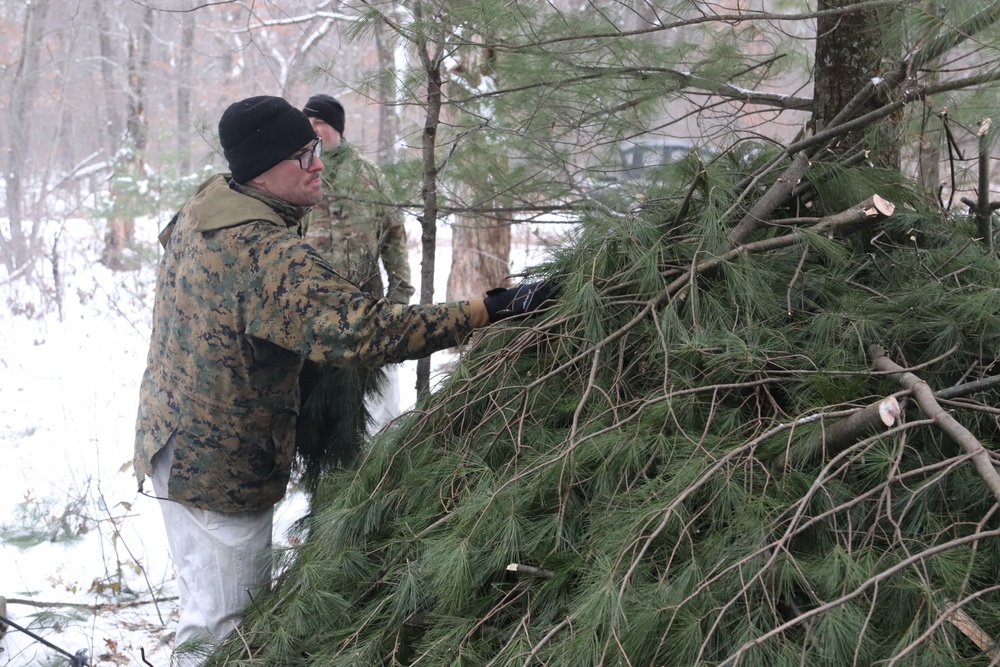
[244,225,474,366]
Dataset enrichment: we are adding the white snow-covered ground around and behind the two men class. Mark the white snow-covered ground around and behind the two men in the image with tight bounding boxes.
[0,215,564,667]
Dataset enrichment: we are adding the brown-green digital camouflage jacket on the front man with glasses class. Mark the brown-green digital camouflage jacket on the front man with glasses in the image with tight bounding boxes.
[134,175,473,512]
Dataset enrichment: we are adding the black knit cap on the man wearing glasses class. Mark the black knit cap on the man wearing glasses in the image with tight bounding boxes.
[219,95,316,183]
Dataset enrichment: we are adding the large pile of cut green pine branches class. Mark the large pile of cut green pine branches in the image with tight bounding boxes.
[212,146,1000,667]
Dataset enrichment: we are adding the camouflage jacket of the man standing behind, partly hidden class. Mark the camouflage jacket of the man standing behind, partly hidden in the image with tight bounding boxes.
[302,144,414,303]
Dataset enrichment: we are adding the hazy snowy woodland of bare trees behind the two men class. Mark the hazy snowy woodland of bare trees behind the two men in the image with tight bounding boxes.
[0,0,995,308]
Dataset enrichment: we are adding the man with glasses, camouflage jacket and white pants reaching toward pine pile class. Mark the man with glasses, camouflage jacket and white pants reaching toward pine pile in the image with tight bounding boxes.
[134,96,549,665]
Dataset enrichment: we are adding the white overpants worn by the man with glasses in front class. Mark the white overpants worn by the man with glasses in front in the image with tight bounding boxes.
[153,442,274,667]
